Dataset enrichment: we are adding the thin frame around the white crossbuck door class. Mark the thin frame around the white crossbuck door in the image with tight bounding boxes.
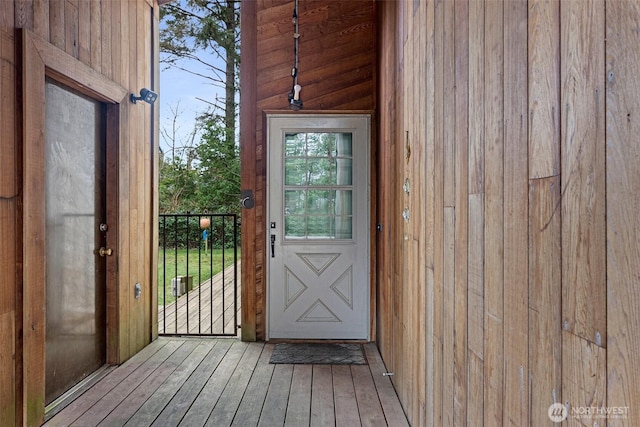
[263,110,376,342]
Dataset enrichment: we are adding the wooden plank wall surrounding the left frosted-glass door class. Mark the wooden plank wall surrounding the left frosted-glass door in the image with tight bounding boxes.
[0,0,159,425]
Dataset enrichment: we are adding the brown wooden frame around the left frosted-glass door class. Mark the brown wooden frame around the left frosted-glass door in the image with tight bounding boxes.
[18,29,128,425]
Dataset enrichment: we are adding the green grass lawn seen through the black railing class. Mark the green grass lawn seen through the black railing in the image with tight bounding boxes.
[158,248,240,305]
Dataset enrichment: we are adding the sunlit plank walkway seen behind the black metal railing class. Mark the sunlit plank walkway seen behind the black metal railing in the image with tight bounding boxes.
[158,262,240,335]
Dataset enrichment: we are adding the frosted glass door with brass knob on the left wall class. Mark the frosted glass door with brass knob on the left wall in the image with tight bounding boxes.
[45,81,106,404]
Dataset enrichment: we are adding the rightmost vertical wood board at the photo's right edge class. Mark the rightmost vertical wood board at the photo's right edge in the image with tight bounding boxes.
[601,1,640,425]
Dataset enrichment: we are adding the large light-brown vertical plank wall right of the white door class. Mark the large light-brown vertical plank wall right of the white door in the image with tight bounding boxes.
[376,0,640,426]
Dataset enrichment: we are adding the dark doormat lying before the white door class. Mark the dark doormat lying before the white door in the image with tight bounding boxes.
[269,343,367,365]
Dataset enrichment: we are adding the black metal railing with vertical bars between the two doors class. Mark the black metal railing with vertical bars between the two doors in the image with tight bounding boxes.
[158,213,240,336]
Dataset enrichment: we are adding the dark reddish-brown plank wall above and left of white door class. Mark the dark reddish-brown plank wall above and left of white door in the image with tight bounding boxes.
[240,0,376,339]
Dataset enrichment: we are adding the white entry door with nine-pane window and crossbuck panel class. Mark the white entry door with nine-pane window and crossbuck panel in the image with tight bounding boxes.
[267,114,370,339]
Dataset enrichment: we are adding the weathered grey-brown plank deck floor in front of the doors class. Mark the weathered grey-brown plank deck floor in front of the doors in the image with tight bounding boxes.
[45,337,408,427]
